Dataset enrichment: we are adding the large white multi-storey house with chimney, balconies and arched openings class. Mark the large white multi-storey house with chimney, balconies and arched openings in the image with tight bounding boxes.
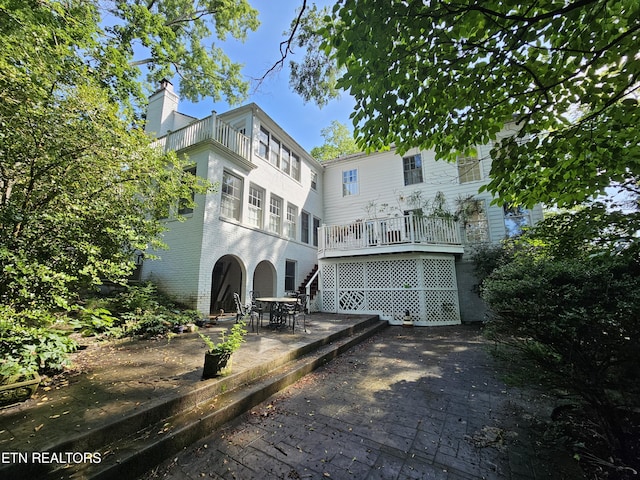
[142,81,542,325]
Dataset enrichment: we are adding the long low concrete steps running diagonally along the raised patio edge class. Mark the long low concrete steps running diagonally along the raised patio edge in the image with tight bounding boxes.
[20,317,388,480]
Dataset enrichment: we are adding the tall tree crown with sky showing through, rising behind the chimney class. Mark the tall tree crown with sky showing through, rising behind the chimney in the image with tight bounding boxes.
[102,0,260,104]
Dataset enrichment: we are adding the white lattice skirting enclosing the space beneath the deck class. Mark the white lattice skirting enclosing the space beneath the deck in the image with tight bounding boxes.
[319,254,460,326]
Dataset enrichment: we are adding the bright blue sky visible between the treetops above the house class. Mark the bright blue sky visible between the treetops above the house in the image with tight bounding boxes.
[178,0,354,151]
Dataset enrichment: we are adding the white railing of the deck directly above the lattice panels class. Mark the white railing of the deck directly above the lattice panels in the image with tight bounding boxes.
[318,214,464,258]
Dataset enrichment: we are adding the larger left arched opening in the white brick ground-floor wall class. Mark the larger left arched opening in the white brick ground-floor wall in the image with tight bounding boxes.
[209,255,244,314]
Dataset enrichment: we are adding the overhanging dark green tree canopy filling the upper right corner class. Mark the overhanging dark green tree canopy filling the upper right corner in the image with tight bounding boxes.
[292,0,640,210]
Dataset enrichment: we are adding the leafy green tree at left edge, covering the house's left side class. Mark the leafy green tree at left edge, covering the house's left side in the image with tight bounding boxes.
[0,1,207,311]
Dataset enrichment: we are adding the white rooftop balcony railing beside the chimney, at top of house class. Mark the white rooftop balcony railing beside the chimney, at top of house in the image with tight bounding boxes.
[152,113,251,161]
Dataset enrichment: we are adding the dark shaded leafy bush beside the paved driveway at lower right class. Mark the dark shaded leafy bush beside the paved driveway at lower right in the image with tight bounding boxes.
[483,252,640,468]
